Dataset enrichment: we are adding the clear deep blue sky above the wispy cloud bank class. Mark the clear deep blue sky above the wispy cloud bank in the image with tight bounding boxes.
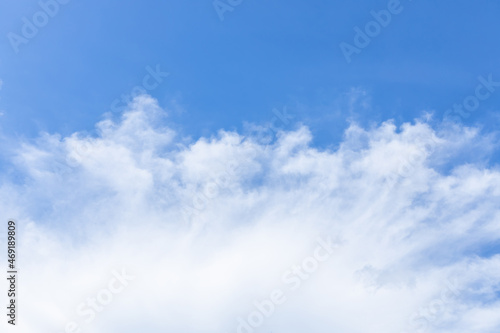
[0,1,500,144]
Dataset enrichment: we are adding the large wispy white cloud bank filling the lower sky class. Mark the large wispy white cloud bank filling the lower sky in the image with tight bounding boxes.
[0,96,500,333]
